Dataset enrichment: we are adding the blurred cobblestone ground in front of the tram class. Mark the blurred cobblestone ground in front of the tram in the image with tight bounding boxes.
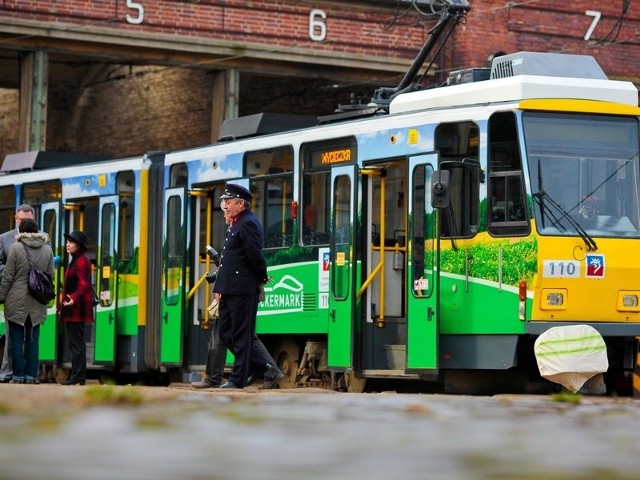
[0,385,640,480]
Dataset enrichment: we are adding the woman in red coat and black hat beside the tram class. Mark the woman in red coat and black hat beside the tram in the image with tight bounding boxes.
[59,230,94,385]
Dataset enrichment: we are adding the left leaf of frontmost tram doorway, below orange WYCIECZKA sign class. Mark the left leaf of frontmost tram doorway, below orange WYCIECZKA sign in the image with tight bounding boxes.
[327,165,357,368]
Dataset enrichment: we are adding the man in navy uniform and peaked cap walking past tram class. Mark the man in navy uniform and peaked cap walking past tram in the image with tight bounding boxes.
[213,184,268,388]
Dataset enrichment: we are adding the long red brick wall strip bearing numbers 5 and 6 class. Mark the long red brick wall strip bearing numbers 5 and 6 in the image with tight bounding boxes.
[0,0,425,58]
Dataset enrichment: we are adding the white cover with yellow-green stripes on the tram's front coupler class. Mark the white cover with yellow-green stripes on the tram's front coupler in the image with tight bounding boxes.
[533,325,609,393]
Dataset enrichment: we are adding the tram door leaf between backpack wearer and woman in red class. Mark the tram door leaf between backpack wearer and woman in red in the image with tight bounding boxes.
[39,202,64,362]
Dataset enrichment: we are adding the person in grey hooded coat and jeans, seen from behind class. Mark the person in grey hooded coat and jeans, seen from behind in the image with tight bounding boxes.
[0,218,54,384]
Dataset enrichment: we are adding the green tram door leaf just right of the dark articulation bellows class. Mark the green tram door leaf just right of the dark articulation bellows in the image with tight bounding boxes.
[160,187,187,365]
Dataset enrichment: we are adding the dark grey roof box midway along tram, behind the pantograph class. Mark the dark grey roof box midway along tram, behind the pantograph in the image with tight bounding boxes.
[218,113,317,142]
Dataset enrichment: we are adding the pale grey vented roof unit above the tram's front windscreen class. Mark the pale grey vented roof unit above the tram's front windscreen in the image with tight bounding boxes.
[491,52,607,80]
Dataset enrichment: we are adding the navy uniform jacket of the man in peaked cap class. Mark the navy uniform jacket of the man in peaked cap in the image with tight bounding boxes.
[213,211,267,295]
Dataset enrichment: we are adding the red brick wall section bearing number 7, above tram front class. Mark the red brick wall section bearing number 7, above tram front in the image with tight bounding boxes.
[446,0,640,84]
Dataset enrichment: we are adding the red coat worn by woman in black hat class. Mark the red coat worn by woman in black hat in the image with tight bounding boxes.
[59,253,93,323]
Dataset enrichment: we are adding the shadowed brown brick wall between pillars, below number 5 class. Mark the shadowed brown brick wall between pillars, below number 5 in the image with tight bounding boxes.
[47,66,212,157]
